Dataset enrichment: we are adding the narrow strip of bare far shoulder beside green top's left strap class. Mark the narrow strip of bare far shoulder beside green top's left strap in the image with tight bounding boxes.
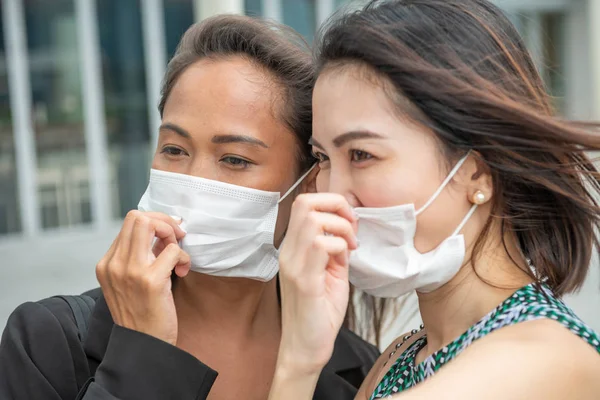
[355,330,425,400]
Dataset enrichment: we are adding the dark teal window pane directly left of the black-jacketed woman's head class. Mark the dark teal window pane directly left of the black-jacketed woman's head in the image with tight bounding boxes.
[97,0,150,218]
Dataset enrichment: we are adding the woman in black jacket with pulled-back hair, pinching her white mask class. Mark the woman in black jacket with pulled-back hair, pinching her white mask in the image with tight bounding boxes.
[0,16,379,400]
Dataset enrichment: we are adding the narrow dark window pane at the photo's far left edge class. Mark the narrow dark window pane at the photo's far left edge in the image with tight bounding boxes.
[0,4,21,235]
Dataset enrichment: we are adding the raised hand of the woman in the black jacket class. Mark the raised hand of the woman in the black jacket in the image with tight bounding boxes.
[96,211,190,345]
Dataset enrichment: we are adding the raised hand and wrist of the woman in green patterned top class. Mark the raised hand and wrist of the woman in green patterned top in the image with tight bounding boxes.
[278,193,357,376]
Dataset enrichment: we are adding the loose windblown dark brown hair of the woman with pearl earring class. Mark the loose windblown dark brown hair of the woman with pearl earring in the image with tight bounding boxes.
[317,0,600,340]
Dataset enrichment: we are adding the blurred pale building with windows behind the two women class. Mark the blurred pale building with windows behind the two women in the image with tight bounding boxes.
[0,0,600,341]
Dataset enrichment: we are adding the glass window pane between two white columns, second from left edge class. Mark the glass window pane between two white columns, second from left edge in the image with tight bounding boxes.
[24,0,91,228]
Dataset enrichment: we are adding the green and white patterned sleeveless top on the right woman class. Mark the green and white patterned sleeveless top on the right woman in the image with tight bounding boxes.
[371,284,600,400]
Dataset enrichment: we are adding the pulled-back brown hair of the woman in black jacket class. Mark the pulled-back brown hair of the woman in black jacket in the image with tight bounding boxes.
[158,15,315,174]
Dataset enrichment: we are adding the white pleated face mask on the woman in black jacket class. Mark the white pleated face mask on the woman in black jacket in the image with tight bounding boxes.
[138,166,314,282]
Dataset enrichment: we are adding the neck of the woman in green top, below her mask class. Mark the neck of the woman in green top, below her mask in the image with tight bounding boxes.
[418,238,533,354]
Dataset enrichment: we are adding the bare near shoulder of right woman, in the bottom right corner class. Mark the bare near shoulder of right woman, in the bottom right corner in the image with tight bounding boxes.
[400,319,600,400]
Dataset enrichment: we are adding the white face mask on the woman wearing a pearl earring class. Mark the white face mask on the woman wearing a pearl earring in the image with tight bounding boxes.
[350,154,477,297]
